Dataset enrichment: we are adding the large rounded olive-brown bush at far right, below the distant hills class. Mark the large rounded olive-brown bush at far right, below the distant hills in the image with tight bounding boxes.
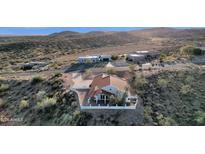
[180,45,203,56]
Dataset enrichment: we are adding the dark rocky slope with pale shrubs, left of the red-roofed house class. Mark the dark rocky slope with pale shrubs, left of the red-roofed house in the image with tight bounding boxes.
[0,74,91,125]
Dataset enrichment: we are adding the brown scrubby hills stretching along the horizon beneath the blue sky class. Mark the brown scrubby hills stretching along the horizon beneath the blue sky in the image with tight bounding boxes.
[0,28,205,65]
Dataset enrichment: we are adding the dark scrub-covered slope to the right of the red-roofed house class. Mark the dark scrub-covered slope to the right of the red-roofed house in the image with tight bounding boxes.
[132,67,205,125]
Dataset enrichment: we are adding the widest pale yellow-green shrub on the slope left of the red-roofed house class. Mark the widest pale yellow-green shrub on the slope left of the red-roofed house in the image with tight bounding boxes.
[37,97,57,109]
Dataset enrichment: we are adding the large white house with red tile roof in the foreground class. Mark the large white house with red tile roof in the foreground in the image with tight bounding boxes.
[87,74,137,104]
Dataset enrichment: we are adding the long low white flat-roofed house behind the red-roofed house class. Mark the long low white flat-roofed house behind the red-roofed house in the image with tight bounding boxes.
[78,55,111,63]
